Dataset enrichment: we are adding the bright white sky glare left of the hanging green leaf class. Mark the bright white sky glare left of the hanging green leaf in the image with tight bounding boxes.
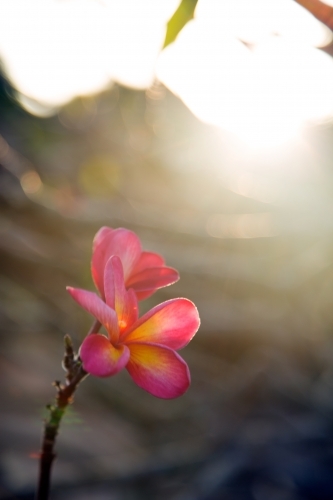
[0,0,179,114]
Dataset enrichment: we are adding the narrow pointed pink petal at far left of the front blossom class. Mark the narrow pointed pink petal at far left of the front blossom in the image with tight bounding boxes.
[67,286,118,341]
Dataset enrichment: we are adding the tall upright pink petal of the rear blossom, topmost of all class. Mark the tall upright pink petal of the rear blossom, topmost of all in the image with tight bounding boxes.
[91,227,141,297]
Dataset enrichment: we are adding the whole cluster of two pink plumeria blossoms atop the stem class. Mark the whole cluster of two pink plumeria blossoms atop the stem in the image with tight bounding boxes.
[67,227,200,399]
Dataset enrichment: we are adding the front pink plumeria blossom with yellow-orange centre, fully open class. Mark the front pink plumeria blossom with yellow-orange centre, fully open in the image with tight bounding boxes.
[67,256,200,399]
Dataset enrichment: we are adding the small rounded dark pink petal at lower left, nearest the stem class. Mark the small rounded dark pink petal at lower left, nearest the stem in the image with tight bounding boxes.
[79,333,130,377]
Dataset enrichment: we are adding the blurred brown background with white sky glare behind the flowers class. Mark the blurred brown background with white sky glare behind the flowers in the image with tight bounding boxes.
[0,0,333,500]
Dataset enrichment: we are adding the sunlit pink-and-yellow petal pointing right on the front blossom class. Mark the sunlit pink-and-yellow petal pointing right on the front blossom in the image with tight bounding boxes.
[122,299,200,349]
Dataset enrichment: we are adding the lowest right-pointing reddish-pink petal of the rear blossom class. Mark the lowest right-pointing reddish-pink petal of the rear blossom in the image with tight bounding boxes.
[126,267,179,300]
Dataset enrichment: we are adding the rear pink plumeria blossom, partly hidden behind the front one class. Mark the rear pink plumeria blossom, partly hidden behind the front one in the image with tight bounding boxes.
[91,227,179,300]
